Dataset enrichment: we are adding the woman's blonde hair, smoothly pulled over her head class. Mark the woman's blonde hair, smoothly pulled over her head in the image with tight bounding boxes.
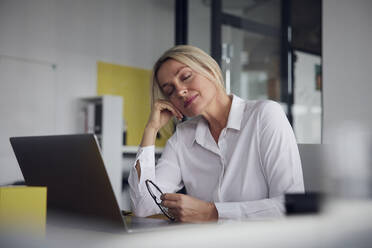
[151,45,225,104]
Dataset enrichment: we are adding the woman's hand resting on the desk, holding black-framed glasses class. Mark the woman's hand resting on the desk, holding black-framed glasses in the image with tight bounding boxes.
[161,194,218,222]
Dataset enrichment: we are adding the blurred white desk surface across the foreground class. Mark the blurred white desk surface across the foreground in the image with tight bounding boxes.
[2,201,372,248]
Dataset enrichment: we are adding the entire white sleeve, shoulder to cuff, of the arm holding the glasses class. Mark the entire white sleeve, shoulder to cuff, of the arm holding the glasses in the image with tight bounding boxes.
[215,101,304,219]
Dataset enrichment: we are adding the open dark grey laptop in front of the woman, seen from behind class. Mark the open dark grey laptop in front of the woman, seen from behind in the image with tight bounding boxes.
[10,134,174,232]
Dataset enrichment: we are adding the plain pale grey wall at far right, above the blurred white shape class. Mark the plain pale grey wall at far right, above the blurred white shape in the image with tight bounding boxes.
[322,0,372,143]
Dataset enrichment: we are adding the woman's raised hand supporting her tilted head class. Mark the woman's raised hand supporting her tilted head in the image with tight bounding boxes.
[146,100,183,131]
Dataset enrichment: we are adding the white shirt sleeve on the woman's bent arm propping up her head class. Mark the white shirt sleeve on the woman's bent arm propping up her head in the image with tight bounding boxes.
[128,138,183,217]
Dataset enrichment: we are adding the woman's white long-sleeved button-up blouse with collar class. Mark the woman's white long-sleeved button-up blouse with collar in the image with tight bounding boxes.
[128,95,304,219]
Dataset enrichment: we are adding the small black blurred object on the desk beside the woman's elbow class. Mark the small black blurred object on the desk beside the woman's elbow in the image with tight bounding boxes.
[285,192,323,215]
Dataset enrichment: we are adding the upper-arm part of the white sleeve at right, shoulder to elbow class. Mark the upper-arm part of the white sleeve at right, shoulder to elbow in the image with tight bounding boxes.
[259,101,304,198]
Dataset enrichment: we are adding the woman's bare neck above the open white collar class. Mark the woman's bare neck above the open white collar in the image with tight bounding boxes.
[202,90,232,136]
